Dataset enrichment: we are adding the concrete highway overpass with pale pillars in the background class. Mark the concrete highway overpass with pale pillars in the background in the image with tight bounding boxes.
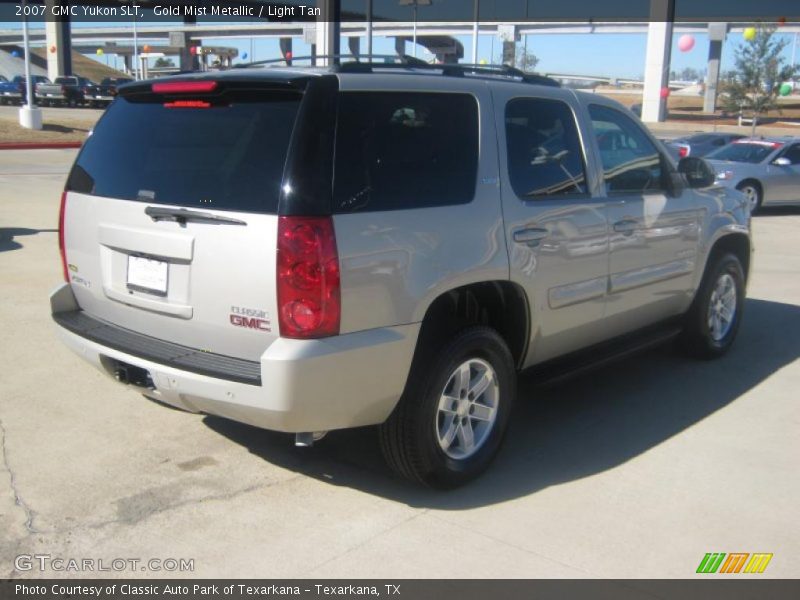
[0,0,800,121]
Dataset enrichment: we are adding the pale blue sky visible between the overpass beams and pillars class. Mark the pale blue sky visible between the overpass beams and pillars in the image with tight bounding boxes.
[0,22,800,78]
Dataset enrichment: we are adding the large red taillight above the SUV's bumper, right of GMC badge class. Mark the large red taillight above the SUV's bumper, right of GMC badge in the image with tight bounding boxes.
[277,217,341,338]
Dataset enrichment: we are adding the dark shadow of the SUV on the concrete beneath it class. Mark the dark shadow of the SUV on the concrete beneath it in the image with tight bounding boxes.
[205,299,800,510]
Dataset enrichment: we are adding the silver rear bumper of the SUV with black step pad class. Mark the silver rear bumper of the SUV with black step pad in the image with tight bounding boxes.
[50,284,419,433]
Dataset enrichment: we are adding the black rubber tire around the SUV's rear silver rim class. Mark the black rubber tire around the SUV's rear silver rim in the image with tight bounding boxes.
[380,326,516,489]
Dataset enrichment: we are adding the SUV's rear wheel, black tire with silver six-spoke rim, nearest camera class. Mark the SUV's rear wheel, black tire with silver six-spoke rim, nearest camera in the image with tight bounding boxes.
[380,326,516,488]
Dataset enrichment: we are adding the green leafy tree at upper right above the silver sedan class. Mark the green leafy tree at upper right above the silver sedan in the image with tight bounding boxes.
[721,25,797,135]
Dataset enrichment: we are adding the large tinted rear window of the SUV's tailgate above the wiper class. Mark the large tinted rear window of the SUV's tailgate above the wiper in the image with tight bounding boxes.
[67,91,301,214]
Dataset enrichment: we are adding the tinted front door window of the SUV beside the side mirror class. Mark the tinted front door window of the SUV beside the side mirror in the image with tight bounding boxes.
[589,104,664,194]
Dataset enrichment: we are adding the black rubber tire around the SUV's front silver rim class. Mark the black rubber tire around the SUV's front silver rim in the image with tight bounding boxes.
[681,254,745,359]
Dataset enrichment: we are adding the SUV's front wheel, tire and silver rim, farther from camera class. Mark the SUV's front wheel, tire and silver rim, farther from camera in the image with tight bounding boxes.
[682,254,745,358]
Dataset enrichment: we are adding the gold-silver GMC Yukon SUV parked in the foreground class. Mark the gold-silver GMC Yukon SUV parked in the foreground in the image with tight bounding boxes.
[51,63,751,487]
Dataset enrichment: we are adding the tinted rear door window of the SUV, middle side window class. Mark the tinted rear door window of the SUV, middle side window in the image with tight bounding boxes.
[505,98,586,198]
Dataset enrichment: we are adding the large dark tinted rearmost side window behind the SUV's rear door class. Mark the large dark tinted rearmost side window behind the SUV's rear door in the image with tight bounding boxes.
[333,92,478,213]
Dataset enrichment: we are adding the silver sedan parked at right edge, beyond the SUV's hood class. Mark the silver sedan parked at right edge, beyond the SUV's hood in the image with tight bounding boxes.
[706,136,800,212]
